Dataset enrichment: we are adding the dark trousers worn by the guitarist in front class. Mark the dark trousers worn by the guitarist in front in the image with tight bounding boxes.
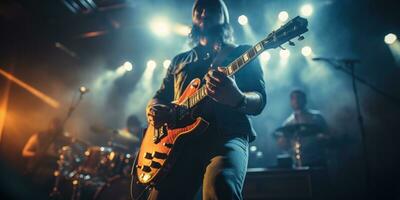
[148,131,249,200]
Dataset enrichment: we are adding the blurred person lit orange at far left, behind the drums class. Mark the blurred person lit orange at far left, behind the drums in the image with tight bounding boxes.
[22,118,71,189]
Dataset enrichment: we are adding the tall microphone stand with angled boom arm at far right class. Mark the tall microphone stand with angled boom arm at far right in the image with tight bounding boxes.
[313,58,400,198]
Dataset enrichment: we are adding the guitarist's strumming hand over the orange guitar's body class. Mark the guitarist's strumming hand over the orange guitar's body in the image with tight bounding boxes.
[147,103,176,128]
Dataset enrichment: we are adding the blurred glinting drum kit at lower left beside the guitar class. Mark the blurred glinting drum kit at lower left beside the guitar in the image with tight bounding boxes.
[50,129,136,200]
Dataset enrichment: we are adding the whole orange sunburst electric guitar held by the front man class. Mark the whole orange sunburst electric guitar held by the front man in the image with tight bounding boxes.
[132,17,308,193]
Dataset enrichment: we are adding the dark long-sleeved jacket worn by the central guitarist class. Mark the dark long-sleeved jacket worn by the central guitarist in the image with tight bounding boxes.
[149,45,266,141]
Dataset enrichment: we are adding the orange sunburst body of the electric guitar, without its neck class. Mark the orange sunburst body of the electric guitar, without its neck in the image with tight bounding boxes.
[133,79,208,185]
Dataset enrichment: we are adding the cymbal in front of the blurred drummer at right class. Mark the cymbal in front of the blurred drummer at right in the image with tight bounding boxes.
[275,124,323,138]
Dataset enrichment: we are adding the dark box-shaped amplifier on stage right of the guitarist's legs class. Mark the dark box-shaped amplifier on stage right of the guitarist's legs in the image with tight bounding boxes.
[243,168,330,200]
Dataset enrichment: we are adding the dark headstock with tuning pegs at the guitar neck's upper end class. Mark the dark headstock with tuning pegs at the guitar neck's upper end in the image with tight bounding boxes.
[261,16,308,49]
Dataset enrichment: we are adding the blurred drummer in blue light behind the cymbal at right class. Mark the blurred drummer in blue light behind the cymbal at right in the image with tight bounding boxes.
[275,90,330,167]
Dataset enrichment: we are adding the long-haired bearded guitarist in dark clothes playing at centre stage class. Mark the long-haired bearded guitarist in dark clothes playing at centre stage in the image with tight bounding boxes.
[146,0,266,199]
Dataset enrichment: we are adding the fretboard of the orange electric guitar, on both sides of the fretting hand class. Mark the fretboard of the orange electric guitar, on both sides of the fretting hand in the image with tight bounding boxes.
[182,42,264,109]
